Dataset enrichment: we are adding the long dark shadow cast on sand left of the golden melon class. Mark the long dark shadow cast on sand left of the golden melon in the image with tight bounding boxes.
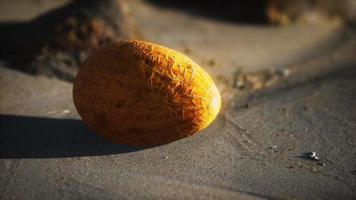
[0,115,143,158]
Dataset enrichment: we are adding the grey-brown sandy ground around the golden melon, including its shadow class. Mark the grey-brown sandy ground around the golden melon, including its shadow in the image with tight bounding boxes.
[0,1,356,199]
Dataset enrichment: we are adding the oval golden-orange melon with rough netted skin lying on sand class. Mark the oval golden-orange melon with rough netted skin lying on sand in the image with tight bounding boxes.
[73,40,221,146]
